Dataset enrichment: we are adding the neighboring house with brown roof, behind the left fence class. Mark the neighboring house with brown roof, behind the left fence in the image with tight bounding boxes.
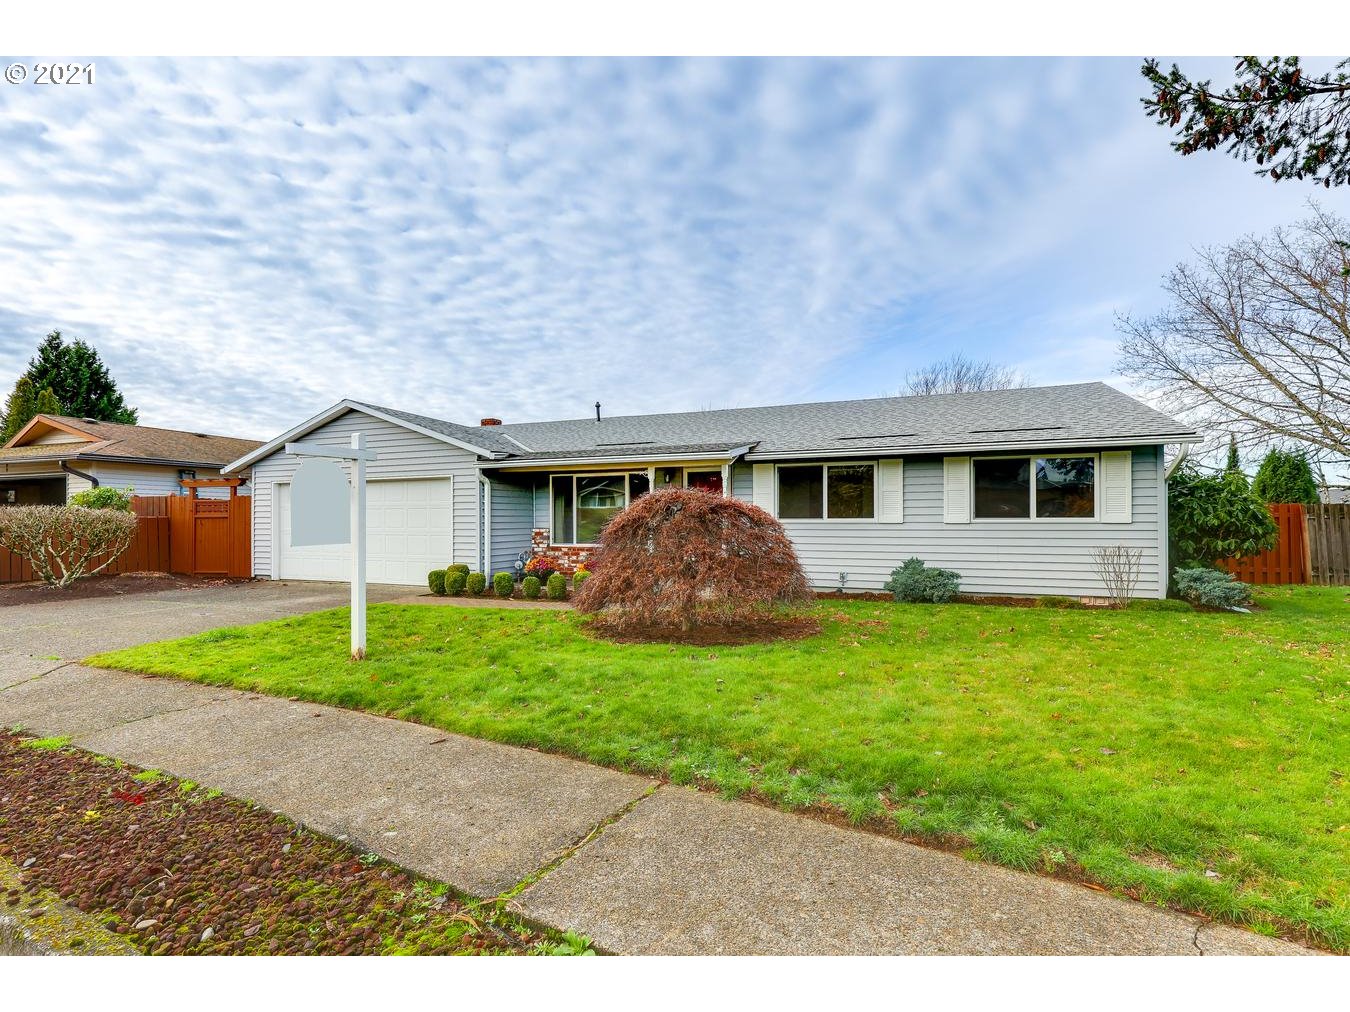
[0,414,262,506]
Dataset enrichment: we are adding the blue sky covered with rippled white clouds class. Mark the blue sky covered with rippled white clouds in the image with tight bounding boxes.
[0,57,1350,437]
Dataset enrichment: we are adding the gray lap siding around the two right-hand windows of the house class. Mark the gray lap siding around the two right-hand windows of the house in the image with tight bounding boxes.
[732,447,1166,598]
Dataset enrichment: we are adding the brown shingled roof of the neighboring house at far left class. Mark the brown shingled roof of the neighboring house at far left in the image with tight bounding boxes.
[0,414,261,467]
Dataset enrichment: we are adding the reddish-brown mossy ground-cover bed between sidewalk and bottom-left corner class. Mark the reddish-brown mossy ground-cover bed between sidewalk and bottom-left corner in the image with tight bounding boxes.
[0,733,566,955]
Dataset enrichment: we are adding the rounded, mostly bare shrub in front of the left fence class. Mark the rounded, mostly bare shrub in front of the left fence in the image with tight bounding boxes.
[0,506,136,587]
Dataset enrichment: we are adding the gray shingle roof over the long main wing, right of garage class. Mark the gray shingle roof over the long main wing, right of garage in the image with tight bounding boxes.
[478,383,1199,461]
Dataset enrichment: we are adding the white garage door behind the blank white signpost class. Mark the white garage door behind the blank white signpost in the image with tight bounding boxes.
[275,478,452,587]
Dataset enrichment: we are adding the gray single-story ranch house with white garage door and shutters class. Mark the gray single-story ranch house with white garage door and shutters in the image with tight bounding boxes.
[224,383,1199,596]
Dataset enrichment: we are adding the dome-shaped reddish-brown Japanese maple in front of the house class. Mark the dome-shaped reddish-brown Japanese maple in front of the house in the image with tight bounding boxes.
[576,488,813,638]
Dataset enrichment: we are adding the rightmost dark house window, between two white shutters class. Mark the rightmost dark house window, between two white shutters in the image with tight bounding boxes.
[973,455,1096,519]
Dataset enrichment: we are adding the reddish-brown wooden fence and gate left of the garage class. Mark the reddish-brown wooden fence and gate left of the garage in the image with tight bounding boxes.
[0,490,252,583]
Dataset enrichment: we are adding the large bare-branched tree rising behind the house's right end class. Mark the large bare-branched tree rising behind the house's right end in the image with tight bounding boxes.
[1118,204,1350,461]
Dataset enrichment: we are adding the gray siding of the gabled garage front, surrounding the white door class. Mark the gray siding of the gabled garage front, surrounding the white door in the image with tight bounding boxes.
[252,412,481,578]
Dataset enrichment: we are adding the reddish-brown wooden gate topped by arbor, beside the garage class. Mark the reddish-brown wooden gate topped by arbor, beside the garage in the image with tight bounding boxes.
[167,478,252,579]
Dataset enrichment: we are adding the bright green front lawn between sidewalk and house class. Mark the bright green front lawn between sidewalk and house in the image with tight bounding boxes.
[89,587,1350,951]
